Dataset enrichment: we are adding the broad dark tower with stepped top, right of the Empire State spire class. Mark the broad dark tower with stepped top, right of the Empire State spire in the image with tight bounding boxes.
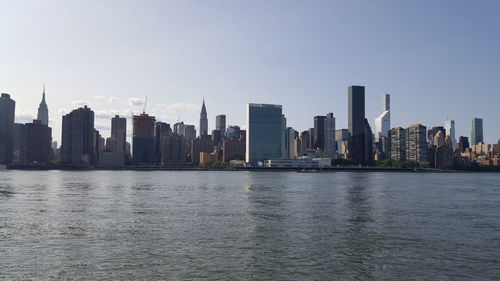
[61,106,99,165]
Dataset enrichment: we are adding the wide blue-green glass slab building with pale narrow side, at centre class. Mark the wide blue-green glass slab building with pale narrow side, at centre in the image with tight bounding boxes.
[246,103,285,165]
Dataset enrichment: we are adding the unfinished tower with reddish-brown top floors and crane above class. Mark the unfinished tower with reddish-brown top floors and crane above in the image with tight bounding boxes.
[132,112,156,165]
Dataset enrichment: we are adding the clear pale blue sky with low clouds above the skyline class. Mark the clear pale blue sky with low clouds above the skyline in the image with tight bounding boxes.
[0,0,500,143]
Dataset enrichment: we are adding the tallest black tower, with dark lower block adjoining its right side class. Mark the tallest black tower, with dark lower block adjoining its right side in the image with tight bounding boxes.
[348,86,372,164]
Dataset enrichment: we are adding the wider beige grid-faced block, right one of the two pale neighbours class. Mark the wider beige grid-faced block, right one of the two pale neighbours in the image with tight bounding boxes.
[406,124,428,163]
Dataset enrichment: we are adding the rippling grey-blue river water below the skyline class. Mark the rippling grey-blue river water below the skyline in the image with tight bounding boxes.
[0,171,500,280]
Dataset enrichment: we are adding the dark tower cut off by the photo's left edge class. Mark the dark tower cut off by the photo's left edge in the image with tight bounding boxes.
[0,94,16,165]
